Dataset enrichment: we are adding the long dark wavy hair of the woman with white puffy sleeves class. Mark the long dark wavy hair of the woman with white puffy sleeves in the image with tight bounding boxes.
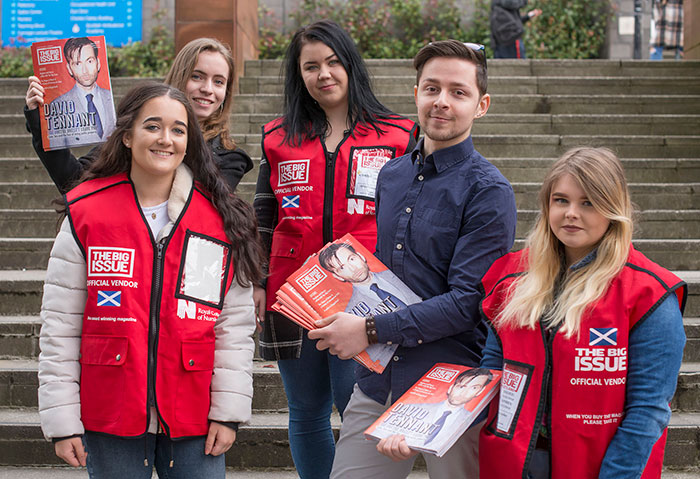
[80,81,263,286]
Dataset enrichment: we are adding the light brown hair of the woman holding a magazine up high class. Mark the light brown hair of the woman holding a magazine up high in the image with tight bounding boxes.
[165,38,236,150]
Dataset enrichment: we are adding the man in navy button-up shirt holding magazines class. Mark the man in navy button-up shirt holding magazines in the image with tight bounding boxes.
[309,40,516,479]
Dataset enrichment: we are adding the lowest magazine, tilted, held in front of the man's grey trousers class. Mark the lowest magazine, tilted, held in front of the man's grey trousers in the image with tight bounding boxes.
[365,363,501,457]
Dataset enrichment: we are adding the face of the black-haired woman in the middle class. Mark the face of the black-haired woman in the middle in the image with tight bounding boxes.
[299,42,348,112]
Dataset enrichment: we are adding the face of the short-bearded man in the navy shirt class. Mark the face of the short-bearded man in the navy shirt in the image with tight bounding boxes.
[414,57,491,155]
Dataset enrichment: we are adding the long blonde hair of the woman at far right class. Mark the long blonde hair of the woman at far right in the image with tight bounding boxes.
[496,147,633,338]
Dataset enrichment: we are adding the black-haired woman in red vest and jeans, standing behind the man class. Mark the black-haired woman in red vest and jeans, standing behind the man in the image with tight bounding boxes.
[254,21,418,479]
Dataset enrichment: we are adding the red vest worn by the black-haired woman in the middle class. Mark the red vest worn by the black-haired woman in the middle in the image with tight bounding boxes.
[262,116,418,310]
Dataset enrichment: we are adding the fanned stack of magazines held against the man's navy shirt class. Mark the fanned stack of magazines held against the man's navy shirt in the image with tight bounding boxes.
[272,234,421,374]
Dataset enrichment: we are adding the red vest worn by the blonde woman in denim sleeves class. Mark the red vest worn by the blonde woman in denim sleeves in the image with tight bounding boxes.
[479,247,687,479]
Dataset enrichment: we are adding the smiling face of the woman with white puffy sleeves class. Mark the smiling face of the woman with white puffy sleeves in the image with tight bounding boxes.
[122,96,187,187]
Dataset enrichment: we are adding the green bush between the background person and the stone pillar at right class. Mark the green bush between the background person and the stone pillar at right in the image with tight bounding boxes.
[525,0,612,59]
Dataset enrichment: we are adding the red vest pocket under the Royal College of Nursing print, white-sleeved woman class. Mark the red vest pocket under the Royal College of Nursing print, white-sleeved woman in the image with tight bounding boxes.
[175,341,214,424]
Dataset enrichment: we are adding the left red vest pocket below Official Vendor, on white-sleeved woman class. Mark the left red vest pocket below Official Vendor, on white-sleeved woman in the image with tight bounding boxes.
[80,334,129,423]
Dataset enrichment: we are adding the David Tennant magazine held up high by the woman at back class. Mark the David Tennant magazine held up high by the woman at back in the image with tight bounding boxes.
[32,36,116,151]
